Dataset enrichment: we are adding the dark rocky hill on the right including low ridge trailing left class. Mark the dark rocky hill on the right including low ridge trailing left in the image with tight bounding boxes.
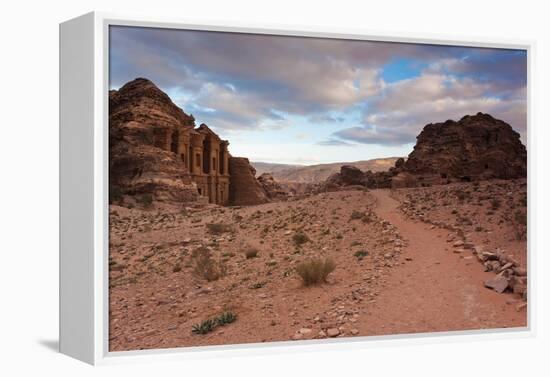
[319,113,527,191]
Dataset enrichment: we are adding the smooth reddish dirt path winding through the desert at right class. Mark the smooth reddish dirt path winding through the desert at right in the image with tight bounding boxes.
[359,190,526,335]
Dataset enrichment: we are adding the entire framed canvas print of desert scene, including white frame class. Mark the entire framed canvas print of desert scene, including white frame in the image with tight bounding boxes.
[60,13,534,363]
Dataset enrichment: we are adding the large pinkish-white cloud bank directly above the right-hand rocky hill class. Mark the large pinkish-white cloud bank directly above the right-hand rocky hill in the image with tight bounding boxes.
[332,72,527,145]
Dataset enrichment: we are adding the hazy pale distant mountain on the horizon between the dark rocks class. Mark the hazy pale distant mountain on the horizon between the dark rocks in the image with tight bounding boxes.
[251,157,399,183]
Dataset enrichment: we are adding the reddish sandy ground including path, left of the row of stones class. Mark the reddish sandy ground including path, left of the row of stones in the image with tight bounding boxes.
[109,184,526,351]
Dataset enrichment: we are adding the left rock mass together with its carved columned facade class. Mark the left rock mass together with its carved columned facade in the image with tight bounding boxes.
[109,78,230,205]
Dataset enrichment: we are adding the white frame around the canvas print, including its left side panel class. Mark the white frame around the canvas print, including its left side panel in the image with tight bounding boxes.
[59,12,536,364]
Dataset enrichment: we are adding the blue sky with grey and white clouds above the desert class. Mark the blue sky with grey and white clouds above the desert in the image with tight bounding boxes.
[109,26,527,165]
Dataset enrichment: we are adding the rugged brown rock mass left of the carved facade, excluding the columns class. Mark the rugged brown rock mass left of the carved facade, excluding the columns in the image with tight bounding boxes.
[109,79,198,204]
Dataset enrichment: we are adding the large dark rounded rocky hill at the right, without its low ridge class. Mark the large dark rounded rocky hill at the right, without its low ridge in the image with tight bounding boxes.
[403,113,527,180]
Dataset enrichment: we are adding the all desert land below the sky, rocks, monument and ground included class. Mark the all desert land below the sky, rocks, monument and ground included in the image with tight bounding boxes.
[109,79,528,351]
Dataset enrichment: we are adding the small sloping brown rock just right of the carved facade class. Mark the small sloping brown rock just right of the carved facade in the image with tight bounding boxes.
[229,156,269,206]
